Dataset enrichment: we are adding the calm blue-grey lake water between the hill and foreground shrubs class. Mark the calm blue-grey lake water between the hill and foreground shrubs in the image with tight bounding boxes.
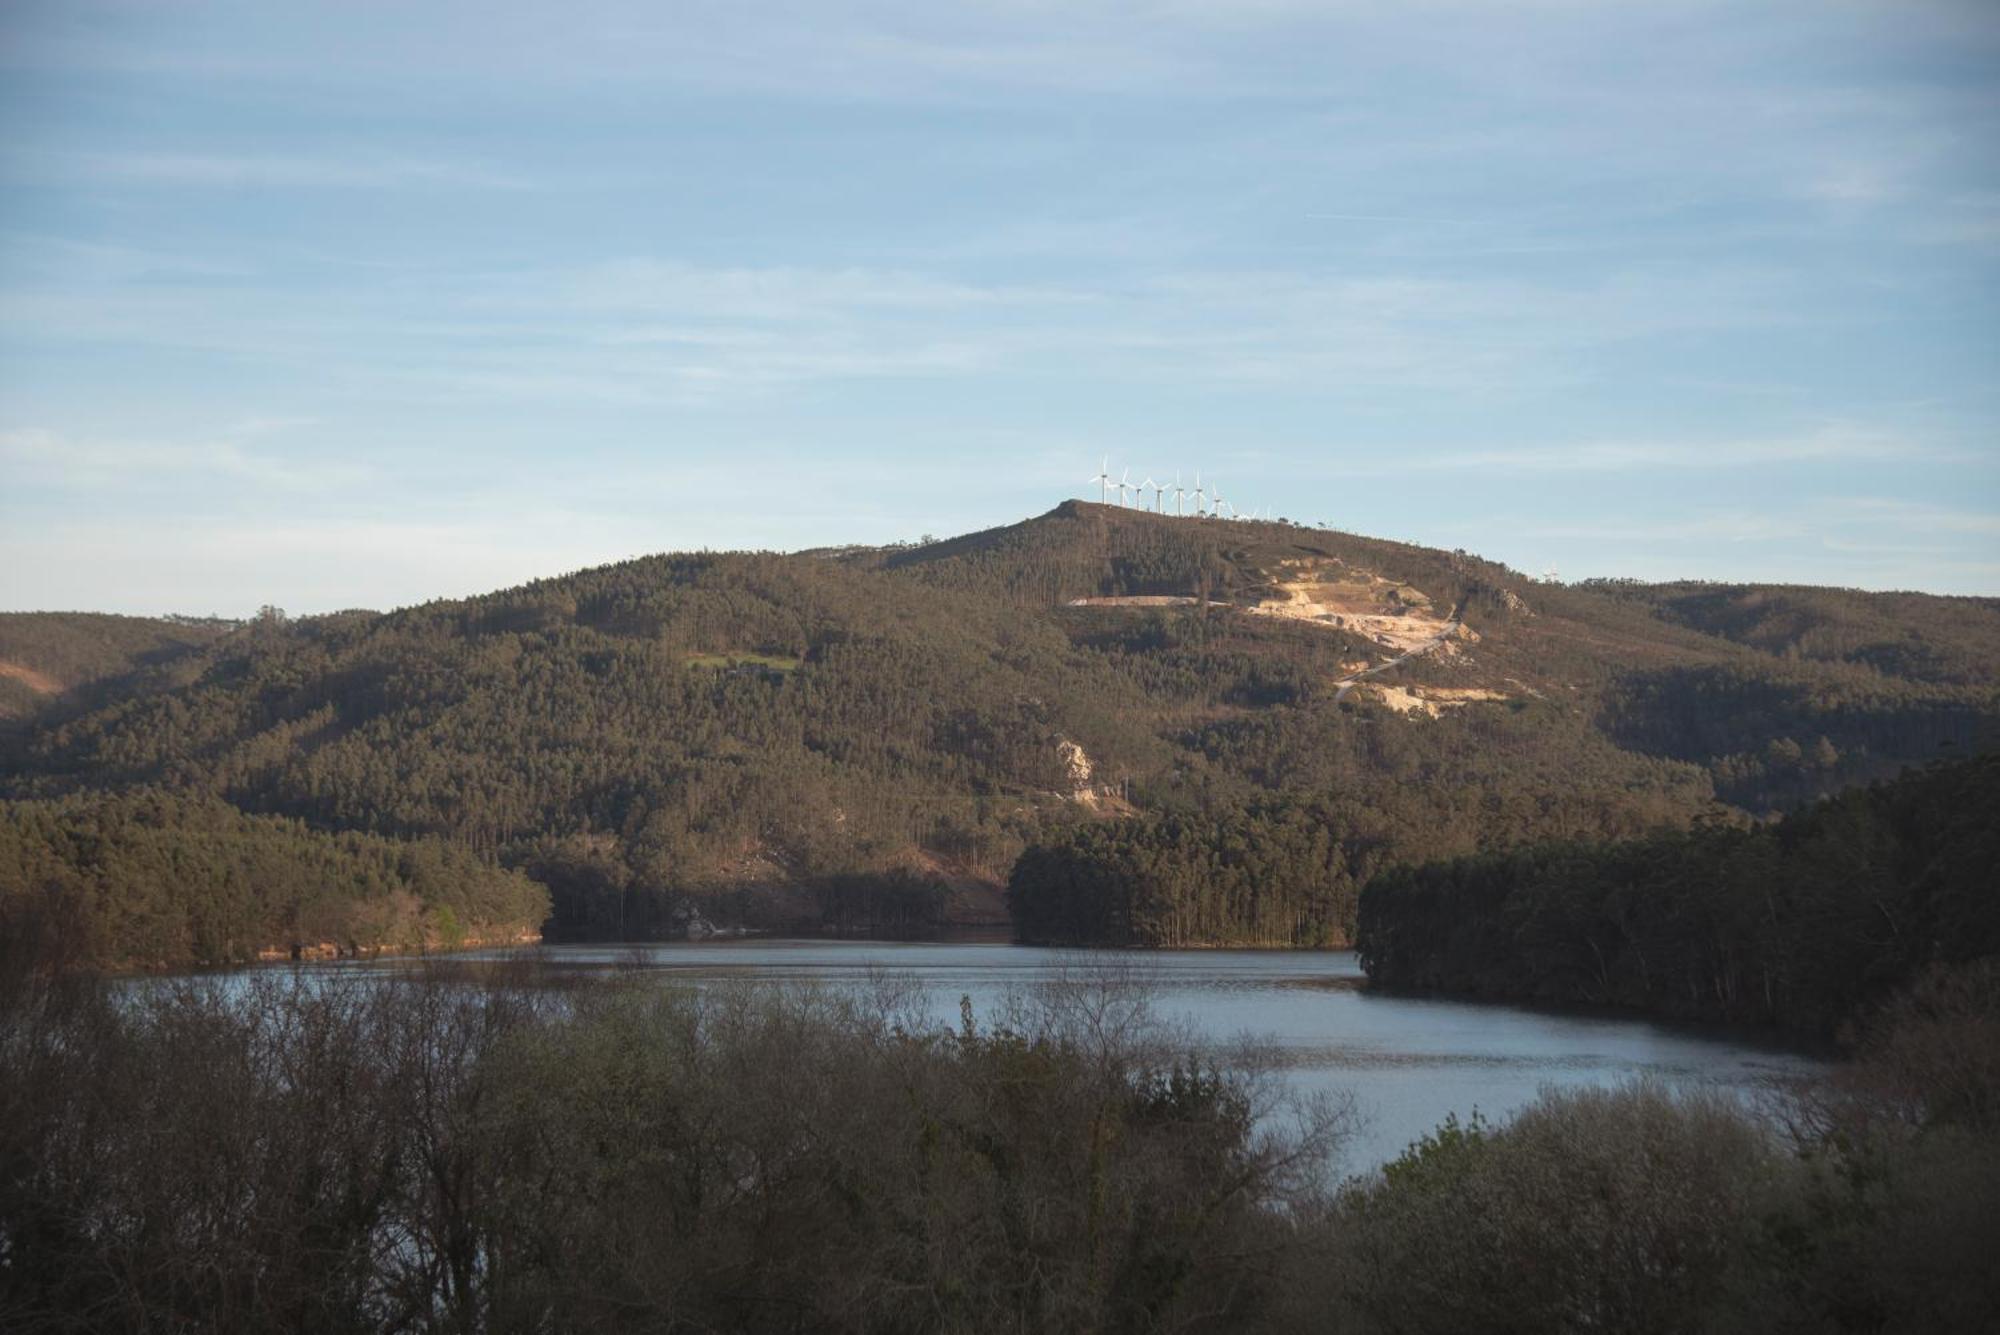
[422,941,1826,1171]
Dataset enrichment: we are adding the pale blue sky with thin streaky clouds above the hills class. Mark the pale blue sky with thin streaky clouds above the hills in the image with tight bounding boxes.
[0,0,2000,616]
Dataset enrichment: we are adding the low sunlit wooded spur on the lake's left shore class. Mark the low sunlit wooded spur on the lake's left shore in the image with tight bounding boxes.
[0,791,548,967]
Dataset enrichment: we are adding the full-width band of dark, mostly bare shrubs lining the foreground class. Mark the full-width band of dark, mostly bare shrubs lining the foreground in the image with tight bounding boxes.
[0,963,2000,1335]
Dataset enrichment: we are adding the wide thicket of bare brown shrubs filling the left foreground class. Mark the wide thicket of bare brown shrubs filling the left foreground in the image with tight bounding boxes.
[0,975,1334,1331]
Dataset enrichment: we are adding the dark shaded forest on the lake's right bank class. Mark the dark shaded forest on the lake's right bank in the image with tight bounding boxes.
[1356,755,2000,1031]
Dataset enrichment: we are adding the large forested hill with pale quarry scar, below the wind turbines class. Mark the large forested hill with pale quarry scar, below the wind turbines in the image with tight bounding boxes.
[0,502,2000,959]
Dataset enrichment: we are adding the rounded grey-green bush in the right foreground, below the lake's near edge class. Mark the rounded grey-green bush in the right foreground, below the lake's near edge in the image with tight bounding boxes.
[1332,1085,1780,1333]
